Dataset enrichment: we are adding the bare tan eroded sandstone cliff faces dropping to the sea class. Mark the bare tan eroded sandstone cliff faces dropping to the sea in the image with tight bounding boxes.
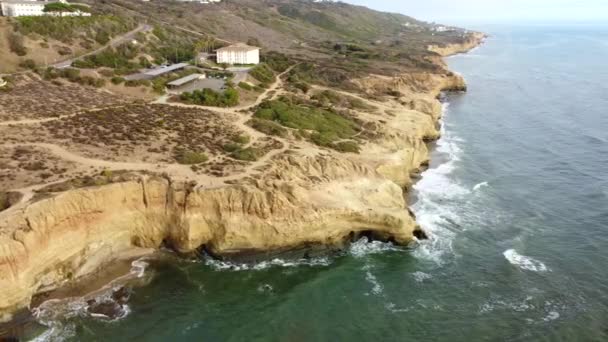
[0,35,484,322]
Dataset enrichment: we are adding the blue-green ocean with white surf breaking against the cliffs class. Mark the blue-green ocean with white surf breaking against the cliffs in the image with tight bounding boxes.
[34,26,608,341]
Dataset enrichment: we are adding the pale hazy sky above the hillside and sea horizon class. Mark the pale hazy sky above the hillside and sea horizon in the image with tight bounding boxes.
[343,0,608,24]
